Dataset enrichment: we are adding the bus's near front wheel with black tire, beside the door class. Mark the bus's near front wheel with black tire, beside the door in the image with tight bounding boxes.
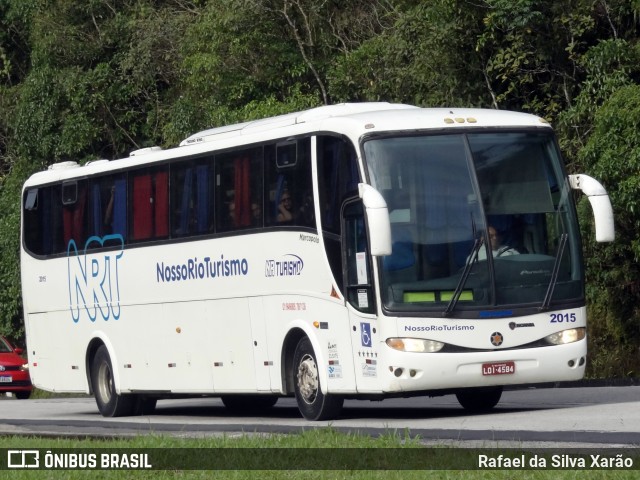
[293,337,344,420]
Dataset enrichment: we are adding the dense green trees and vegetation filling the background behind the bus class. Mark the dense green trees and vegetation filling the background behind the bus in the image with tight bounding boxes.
[0,0,640,378]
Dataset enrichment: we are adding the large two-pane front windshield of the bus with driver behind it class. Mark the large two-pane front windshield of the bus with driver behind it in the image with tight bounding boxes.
[364,131,583,318]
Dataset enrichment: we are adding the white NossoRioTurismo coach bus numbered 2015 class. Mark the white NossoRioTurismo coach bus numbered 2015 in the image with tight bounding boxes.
[21,103,614,420]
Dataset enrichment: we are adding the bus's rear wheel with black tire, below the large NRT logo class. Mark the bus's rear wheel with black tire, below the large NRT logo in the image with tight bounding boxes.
[91,345,137,417]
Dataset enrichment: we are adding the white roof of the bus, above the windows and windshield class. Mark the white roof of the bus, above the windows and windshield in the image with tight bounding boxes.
[25,102,549,187]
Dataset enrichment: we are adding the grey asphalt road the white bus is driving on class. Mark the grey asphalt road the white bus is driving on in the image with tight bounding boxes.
[0,386,640,447]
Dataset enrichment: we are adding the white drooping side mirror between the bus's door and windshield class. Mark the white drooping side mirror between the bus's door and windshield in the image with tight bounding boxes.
[358,183,391,257]
